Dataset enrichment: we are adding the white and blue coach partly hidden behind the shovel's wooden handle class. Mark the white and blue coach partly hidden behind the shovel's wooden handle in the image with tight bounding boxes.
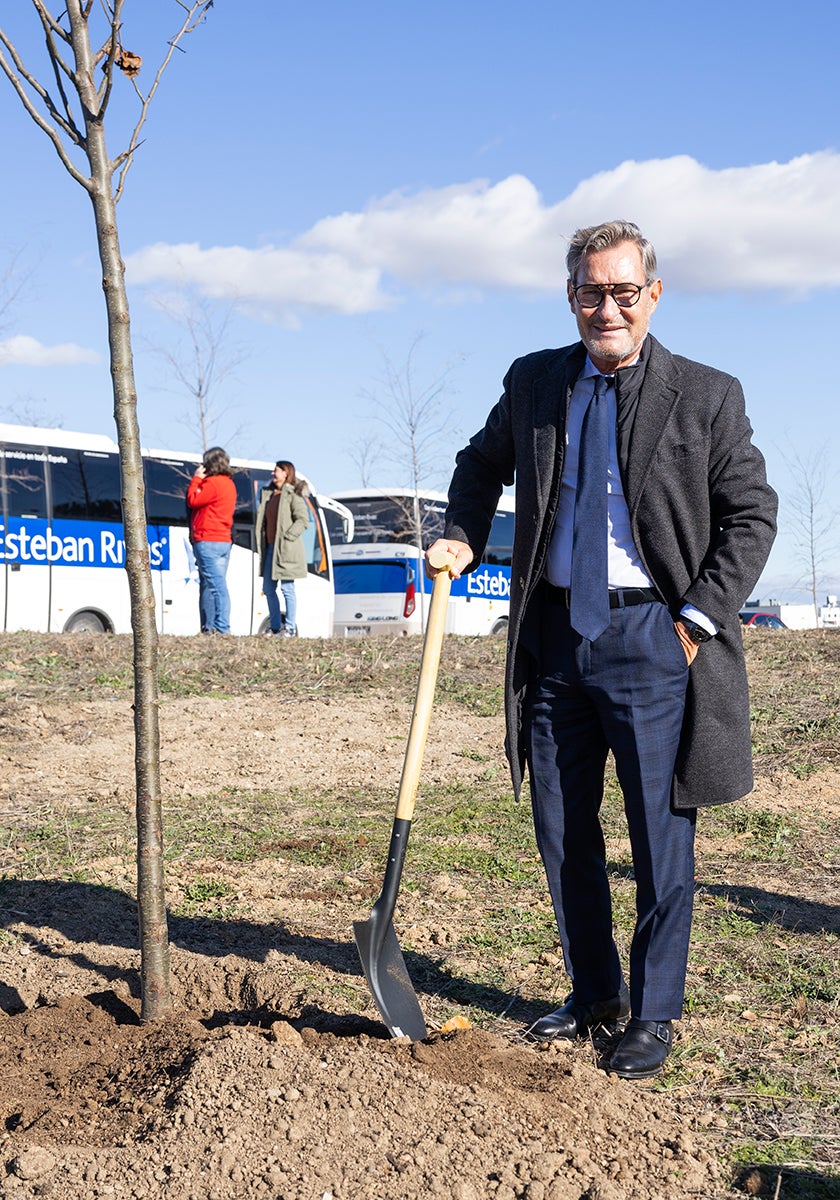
[328,487,514,637]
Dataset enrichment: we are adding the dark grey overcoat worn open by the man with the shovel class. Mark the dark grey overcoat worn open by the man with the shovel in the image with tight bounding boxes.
[446,335,776,808]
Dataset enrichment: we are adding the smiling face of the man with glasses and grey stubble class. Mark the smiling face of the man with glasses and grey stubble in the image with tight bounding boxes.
[568,241,662,374]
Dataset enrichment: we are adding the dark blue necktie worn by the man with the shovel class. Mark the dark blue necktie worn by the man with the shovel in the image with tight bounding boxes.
[569,376,610,642]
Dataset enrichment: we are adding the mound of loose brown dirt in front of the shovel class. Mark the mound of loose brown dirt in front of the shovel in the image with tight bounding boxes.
[0,991,719,1200]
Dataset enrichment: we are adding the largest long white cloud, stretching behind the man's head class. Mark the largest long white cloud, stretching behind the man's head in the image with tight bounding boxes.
[123,150,840,322]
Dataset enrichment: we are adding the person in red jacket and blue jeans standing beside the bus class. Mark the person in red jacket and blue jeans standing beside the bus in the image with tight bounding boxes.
[187,446,236,634]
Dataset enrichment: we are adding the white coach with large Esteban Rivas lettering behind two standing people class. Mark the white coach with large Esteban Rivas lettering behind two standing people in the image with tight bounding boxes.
[0,424,353,637]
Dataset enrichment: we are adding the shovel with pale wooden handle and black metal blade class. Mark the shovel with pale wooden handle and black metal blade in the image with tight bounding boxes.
[353,552,452,1042]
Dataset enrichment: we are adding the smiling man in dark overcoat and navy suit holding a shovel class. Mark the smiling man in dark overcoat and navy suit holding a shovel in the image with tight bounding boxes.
[430,221,776,1079]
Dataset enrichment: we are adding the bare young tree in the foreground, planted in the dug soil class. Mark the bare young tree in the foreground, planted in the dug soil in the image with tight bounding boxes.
[0,0,214,1020]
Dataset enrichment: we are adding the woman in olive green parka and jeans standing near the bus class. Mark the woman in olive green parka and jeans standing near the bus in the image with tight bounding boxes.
[257,460,310,637]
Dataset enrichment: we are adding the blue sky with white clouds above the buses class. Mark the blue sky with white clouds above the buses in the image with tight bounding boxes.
[0,0,840,599]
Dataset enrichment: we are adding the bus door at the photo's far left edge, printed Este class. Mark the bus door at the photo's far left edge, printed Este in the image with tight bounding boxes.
[0,445,50,632]
